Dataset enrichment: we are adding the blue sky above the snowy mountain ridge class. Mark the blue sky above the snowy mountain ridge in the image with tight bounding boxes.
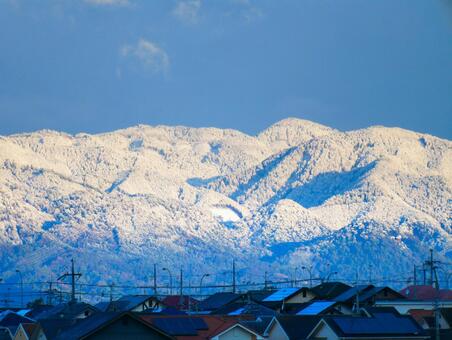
[0,0,452,139]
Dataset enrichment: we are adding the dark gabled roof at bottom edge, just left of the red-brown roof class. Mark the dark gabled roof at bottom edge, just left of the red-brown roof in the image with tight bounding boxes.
[55,312,171,340]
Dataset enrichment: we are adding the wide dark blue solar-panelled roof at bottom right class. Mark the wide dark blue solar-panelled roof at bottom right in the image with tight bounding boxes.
[323,313,425,337]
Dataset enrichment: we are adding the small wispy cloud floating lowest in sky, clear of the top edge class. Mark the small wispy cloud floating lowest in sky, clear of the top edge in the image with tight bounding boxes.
[120,39,170,73]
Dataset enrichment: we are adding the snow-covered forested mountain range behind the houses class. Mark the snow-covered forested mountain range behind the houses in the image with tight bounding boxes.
[0,119,452,284]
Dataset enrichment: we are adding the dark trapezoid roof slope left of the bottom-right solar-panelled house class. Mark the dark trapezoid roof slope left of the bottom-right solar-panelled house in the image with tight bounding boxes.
[269,315,321,340]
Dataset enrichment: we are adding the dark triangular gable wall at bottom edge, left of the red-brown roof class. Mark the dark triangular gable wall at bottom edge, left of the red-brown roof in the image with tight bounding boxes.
[85,316,168,340]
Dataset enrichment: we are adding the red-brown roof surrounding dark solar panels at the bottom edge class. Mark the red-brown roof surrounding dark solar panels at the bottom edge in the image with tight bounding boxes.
[140,315,238,340]
